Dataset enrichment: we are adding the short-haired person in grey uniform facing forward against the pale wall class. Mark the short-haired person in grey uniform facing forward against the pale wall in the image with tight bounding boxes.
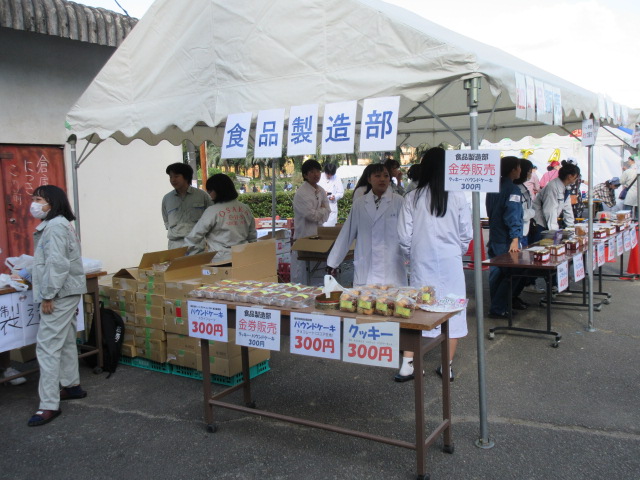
[162,163,213,249]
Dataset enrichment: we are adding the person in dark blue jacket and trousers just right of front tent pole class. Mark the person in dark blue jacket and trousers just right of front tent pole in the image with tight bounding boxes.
[486,156,527,318]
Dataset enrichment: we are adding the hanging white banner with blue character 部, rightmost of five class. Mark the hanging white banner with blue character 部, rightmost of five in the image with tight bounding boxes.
[360,97,400,152]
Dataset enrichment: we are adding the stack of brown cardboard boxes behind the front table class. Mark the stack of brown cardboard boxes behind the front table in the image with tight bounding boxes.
[100,240,277,377]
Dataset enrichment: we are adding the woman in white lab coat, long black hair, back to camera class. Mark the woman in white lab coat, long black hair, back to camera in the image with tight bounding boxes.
[395,148,473,382]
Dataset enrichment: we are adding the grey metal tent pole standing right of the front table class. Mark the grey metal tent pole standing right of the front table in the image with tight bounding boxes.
[464,77,495,449]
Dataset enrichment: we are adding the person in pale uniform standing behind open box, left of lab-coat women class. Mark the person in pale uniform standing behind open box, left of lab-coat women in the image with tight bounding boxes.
[291,160,331,283]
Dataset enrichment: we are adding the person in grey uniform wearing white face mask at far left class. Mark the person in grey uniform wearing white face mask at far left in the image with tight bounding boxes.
[15,185,87,427]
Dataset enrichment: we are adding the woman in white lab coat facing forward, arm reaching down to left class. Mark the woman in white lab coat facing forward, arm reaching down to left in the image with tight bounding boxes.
[327,163,407,286]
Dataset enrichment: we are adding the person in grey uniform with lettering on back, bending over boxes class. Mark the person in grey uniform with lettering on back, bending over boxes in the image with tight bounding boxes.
[184,173,258,261]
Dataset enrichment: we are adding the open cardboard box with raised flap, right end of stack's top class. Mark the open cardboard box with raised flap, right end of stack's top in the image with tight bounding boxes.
[201,239,277,285]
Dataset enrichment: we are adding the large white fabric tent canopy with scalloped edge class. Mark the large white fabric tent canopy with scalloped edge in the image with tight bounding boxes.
[67,0,626,145]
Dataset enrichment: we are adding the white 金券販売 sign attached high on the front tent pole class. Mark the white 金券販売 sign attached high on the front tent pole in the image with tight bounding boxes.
[444,150,500,192]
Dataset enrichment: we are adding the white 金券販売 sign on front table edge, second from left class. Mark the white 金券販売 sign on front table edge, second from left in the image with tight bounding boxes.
[236,307,282,351]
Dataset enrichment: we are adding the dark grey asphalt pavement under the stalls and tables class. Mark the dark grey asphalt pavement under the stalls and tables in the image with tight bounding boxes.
[0,258,640,480]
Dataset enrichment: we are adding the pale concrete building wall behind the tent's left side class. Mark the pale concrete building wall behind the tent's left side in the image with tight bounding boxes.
[0,28,182,272]
